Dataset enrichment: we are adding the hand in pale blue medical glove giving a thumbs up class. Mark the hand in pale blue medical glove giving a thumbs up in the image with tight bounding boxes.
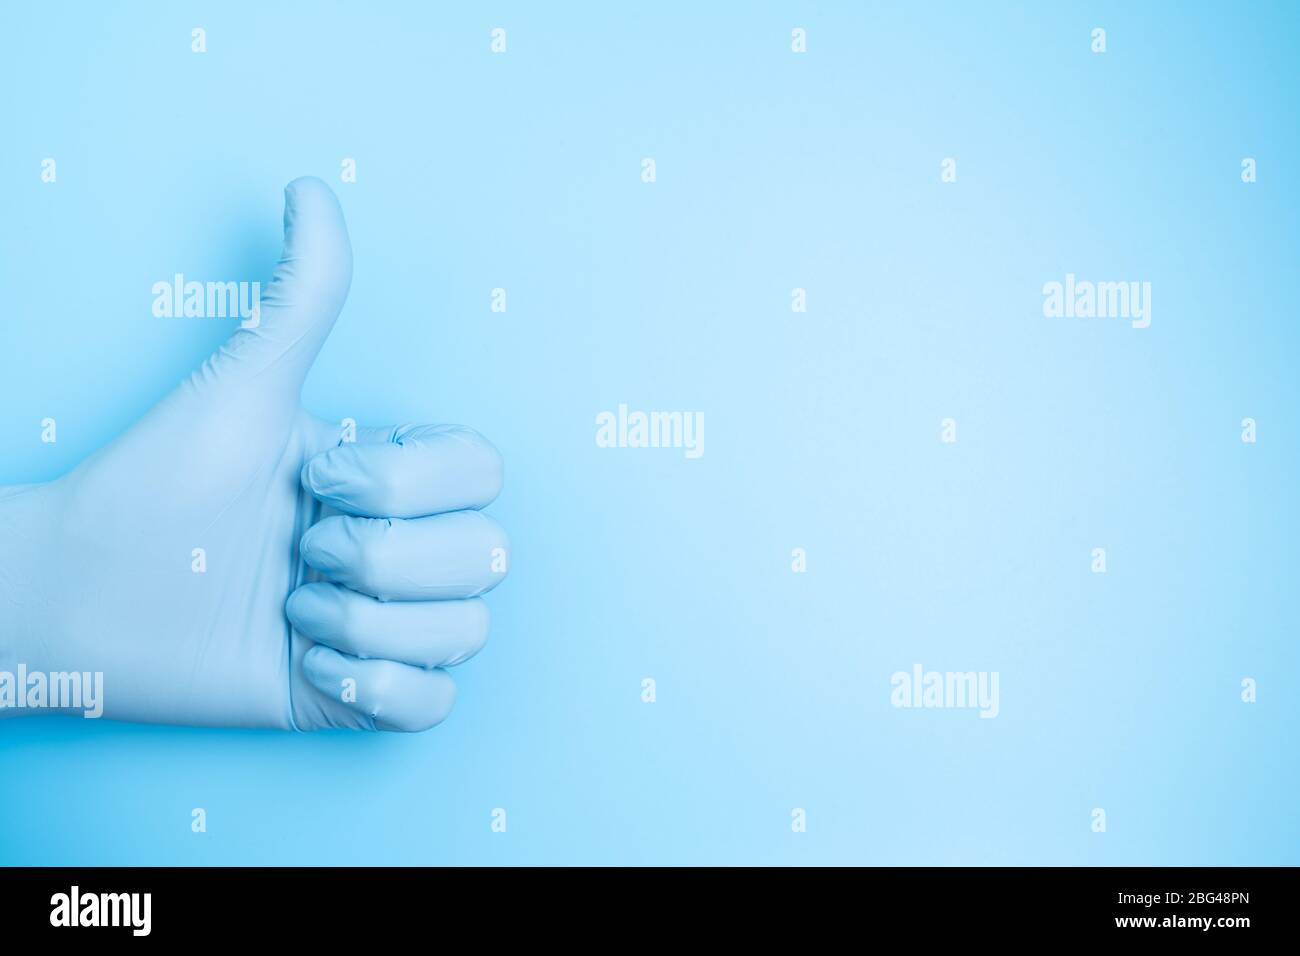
[0,178,507,731]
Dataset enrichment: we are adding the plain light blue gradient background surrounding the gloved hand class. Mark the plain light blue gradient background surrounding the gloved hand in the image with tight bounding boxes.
[0,3,1300,864]
